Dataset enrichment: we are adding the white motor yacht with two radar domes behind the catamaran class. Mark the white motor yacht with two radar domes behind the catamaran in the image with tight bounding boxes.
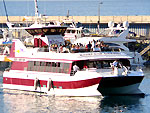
[73,21,145,66]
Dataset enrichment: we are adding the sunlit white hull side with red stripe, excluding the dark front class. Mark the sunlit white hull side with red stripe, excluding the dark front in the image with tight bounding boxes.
[3,72,102,96]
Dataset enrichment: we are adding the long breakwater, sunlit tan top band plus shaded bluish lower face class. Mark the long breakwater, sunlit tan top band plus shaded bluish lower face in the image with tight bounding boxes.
[0,16,150,39]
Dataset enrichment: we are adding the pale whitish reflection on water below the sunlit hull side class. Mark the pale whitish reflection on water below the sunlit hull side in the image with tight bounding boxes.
[3,90,103,113]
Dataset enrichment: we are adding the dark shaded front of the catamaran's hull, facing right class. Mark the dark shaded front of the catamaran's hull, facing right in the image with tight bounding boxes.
[97,76,144,96]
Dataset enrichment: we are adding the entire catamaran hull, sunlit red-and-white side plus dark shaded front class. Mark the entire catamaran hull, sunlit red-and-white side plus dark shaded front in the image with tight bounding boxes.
[3,71,144,96]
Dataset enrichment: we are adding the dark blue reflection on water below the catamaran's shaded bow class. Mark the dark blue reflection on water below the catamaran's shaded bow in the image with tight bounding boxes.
[100,96,143,113]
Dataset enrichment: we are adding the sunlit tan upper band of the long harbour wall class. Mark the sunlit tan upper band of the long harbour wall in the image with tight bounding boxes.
[0,16,150,23]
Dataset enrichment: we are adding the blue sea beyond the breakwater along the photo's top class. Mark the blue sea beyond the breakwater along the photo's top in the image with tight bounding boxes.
[0,0,150,16]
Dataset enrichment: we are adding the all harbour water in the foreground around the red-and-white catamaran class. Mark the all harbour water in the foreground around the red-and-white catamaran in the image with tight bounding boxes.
[0,68,150,113]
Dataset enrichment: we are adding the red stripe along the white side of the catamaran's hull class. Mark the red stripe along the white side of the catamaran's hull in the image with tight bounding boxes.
[3,77,101,89]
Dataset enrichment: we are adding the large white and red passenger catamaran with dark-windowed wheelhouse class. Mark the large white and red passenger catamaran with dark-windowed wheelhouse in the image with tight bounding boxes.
[3,22,144,96]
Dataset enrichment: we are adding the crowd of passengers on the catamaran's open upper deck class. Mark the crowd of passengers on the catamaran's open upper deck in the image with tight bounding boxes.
[45,40,109,53]
